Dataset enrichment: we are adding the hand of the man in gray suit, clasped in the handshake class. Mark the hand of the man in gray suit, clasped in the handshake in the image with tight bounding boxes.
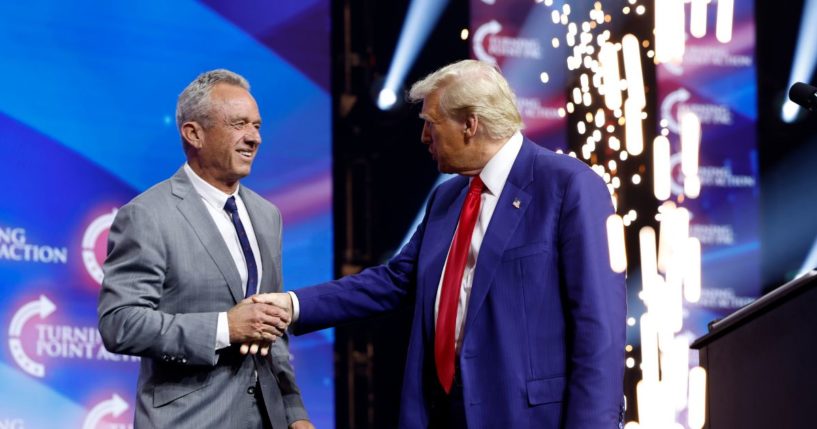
[227,299,292,344]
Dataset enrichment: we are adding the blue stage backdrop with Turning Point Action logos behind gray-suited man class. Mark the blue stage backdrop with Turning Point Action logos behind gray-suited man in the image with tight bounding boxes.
[0,0,334,429]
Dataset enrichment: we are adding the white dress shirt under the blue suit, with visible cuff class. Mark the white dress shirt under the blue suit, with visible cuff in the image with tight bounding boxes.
[289,131,523,353]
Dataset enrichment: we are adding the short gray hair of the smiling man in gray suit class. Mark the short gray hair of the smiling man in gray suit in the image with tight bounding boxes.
[176,69,250,131]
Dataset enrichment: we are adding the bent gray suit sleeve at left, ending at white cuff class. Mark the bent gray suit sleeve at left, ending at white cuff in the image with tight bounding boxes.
[97,203,218,366]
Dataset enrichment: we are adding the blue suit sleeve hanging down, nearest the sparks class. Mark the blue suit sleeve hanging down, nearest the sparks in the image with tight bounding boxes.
[559,170,626,428]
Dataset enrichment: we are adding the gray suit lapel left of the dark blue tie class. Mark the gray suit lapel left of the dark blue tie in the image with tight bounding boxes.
[170,168,244,302]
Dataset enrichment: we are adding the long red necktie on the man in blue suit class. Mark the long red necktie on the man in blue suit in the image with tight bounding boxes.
[434,176,484,393]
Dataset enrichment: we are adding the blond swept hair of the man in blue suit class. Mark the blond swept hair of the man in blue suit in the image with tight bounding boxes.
[408,60,524,140]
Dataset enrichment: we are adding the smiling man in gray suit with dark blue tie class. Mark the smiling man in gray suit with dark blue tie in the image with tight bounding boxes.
[98,70,313,429]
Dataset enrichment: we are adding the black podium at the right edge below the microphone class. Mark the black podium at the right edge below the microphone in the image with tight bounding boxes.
[691,271,817,429]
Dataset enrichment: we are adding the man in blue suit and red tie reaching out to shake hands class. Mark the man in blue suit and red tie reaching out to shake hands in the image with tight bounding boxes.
[257,60,626,429]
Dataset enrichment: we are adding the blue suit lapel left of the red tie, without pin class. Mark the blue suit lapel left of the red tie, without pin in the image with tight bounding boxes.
[421,179,468,338]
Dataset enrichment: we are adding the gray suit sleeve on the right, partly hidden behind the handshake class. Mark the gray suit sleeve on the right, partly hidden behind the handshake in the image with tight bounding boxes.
[269,206,309,425]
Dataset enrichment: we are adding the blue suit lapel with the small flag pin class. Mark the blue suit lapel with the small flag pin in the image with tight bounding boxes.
[464,141,535,335]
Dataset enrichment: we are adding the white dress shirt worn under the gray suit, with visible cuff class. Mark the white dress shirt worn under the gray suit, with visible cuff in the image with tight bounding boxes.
[184,163,264,350]
